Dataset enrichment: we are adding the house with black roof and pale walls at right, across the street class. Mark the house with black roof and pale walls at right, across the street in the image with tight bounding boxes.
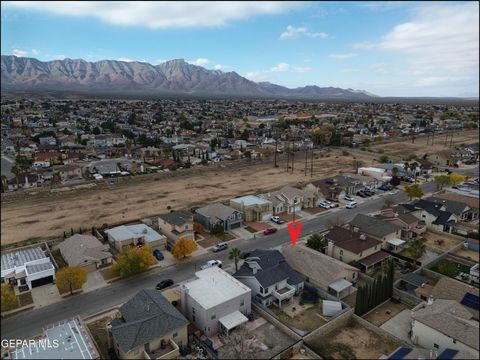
[402,199,458,233]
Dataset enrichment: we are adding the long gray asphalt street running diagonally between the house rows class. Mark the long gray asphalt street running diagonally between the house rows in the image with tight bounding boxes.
[1,182,435,339]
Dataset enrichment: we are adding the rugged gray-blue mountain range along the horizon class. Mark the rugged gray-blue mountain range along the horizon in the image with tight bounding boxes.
[1,55,377,100]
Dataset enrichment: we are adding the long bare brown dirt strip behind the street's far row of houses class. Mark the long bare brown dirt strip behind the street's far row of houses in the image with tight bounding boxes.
[1,150,371,245]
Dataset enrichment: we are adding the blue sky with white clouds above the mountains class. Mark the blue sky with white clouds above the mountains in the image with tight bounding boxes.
[1,1,479,96]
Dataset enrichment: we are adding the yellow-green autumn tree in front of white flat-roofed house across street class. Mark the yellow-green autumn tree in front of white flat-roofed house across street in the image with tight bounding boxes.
[113,246,157,277]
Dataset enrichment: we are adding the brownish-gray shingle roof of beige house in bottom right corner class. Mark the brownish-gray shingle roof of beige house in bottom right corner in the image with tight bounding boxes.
[412,300,479,350]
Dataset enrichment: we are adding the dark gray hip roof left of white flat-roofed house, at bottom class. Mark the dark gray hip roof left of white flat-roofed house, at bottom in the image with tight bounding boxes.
[111,289,188,352]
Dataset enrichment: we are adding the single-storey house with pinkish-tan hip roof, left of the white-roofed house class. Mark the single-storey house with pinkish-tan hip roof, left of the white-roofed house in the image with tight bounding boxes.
[56,234,112,272]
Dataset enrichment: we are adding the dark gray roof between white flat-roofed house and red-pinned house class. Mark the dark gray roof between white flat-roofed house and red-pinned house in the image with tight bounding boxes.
[233,249,304,287]
